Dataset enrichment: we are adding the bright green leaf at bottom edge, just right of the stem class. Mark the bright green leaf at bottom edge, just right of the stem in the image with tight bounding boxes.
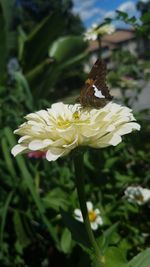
[102,247,127,267]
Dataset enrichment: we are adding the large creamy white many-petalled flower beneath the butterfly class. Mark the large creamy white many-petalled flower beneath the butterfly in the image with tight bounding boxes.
[12,102,140,161]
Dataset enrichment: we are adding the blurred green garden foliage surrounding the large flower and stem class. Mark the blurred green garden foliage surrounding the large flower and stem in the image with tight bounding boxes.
[0,0,150,267]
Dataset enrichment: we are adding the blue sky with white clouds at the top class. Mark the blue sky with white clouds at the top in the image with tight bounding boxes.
[73,0,149,27]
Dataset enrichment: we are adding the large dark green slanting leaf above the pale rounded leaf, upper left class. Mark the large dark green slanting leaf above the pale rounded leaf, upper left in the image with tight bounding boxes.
[23,12,65,71]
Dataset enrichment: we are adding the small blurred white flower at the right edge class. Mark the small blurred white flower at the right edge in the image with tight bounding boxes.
[124,186,150,205]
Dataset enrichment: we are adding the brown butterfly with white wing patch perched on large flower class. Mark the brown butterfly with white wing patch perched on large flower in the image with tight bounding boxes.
[78,59,113,108]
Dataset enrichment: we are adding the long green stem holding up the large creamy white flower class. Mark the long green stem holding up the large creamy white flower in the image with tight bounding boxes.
[74,153,102,267]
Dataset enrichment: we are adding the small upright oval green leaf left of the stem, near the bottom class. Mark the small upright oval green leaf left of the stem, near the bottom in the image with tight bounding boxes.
[60,228,72,253]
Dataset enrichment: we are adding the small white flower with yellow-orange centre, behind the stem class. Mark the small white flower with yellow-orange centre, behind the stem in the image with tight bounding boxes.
[74,201,103,230]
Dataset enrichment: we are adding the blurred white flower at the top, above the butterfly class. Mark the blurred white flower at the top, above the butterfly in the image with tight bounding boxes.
[84,24,115,41]
